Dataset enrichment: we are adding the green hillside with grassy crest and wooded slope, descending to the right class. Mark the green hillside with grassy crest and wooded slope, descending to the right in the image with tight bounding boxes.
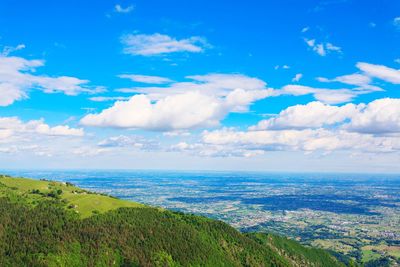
[0,176,342,267]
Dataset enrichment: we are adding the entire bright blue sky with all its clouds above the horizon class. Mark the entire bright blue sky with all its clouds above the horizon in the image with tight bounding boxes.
[0,0,400,172]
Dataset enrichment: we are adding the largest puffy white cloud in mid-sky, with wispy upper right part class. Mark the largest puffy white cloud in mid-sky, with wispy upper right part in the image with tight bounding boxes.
[81,74,272,131]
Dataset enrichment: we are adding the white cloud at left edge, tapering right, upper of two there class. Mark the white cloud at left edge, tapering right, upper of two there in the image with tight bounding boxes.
[0,56,104,106]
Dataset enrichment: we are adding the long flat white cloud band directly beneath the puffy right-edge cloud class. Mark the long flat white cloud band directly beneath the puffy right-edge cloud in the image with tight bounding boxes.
[203,128,400,153]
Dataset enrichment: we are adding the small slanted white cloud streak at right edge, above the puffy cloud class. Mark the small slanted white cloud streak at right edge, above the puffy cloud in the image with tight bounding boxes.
[357,62,400,84]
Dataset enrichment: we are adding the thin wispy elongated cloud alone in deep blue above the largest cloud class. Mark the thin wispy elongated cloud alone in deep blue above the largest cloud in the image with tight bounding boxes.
[121,33,210,56]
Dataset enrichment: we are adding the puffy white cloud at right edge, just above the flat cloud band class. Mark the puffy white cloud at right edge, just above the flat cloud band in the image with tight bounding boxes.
[249,98,400,134]
